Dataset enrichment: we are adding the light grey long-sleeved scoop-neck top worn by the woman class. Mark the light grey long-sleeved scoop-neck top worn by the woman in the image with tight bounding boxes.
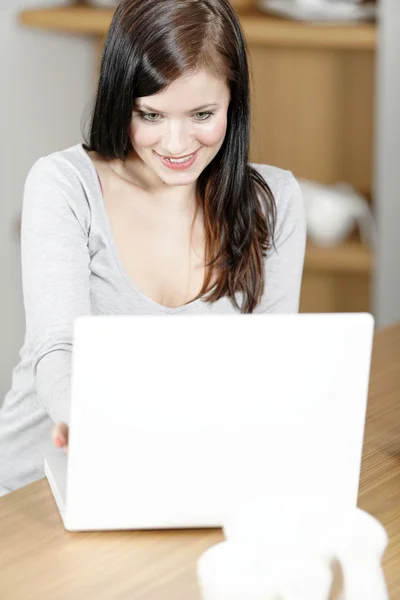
[0,144,306,495]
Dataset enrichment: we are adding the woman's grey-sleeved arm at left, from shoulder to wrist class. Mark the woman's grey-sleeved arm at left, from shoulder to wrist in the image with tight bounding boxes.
[21,157,90,423]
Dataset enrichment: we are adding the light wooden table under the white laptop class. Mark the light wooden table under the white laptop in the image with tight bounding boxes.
[0,325,400,600]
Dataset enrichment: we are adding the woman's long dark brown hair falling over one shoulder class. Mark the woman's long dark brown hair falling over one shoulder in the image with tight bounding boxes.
[84,0,276,313]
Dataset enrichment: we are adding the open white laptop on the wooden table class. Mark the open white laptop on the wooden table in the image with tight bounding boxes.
[45,314,374,531]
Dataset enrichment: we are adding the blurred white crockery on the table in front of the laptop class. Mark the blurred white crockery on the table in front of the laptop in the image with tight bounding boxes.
[197,499,389,600]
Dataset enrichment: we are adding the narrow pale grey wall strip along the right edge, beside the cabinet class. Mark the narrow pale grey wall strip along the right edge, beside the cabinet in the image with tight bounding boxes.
[374,0,400,326]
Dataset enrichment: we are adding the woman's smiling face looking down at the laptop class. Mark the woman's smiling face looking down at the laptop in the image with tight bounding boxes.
[130,71,230,186]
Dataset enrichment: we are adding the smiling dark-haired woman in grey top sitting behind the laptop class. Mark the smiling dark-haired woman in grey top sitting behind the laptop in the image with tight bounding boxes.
[0,0,305,494]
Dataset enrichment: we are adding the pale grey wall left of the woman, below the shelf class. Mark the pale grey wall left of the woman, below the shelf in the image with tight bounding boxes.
[0,0,95,405]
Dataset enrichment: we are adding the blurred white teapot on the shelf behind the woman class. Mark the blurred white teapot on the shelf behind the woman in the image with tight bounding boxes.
[299,179,376,249]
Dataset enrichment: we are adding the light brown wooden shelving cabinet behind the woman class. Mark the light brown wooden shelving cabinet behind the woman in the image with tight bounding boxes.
[20,6,377,312]
